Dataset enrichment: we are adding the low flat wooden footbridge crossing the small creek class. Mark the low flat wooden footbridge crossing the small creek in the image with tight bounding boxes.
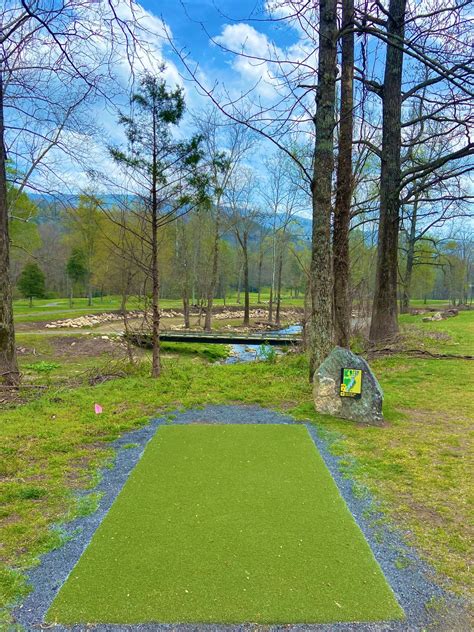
[129,330,301,347]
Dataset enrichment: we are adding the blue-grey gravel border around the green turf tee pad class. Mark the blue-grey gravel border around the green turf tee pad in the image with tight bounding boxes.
[13,405,456,632]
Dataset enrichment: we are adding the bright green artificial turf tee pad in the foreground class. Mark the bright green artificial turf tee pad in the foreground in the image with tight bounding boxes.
[47,424,403,624]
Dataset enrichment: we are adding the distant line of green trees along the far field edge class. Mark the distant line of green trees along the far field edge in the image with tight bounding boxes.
[12,183,474,314]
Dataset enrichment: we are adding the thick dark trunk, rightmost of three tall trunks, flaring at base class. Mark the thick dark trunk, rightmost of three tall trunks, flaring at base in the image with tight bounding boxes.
[370,0,406,343]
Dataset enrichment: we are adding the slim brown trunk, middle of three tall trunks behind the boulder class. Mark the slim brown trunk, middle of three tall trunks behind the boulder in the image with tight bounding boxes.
[333,0,354,347]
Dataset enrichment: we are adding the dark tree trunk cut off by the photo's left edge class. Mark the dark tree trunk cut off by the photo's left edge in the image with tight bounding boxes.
[0,68,20,386]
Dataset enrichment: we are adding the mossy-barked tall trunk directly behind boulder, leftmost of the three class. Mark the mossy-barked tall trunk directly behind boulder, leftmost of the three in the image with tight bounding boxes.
[309,0,337,379]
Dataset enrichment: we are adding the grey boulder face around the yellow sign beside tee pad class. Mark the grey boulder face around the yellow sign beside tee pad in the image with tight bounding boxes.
[313,347,383,426]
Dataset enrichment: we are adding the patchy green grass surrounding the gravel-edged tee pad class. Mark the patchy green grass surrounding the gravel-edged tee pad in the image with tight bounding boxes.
[0,312,474,620]
